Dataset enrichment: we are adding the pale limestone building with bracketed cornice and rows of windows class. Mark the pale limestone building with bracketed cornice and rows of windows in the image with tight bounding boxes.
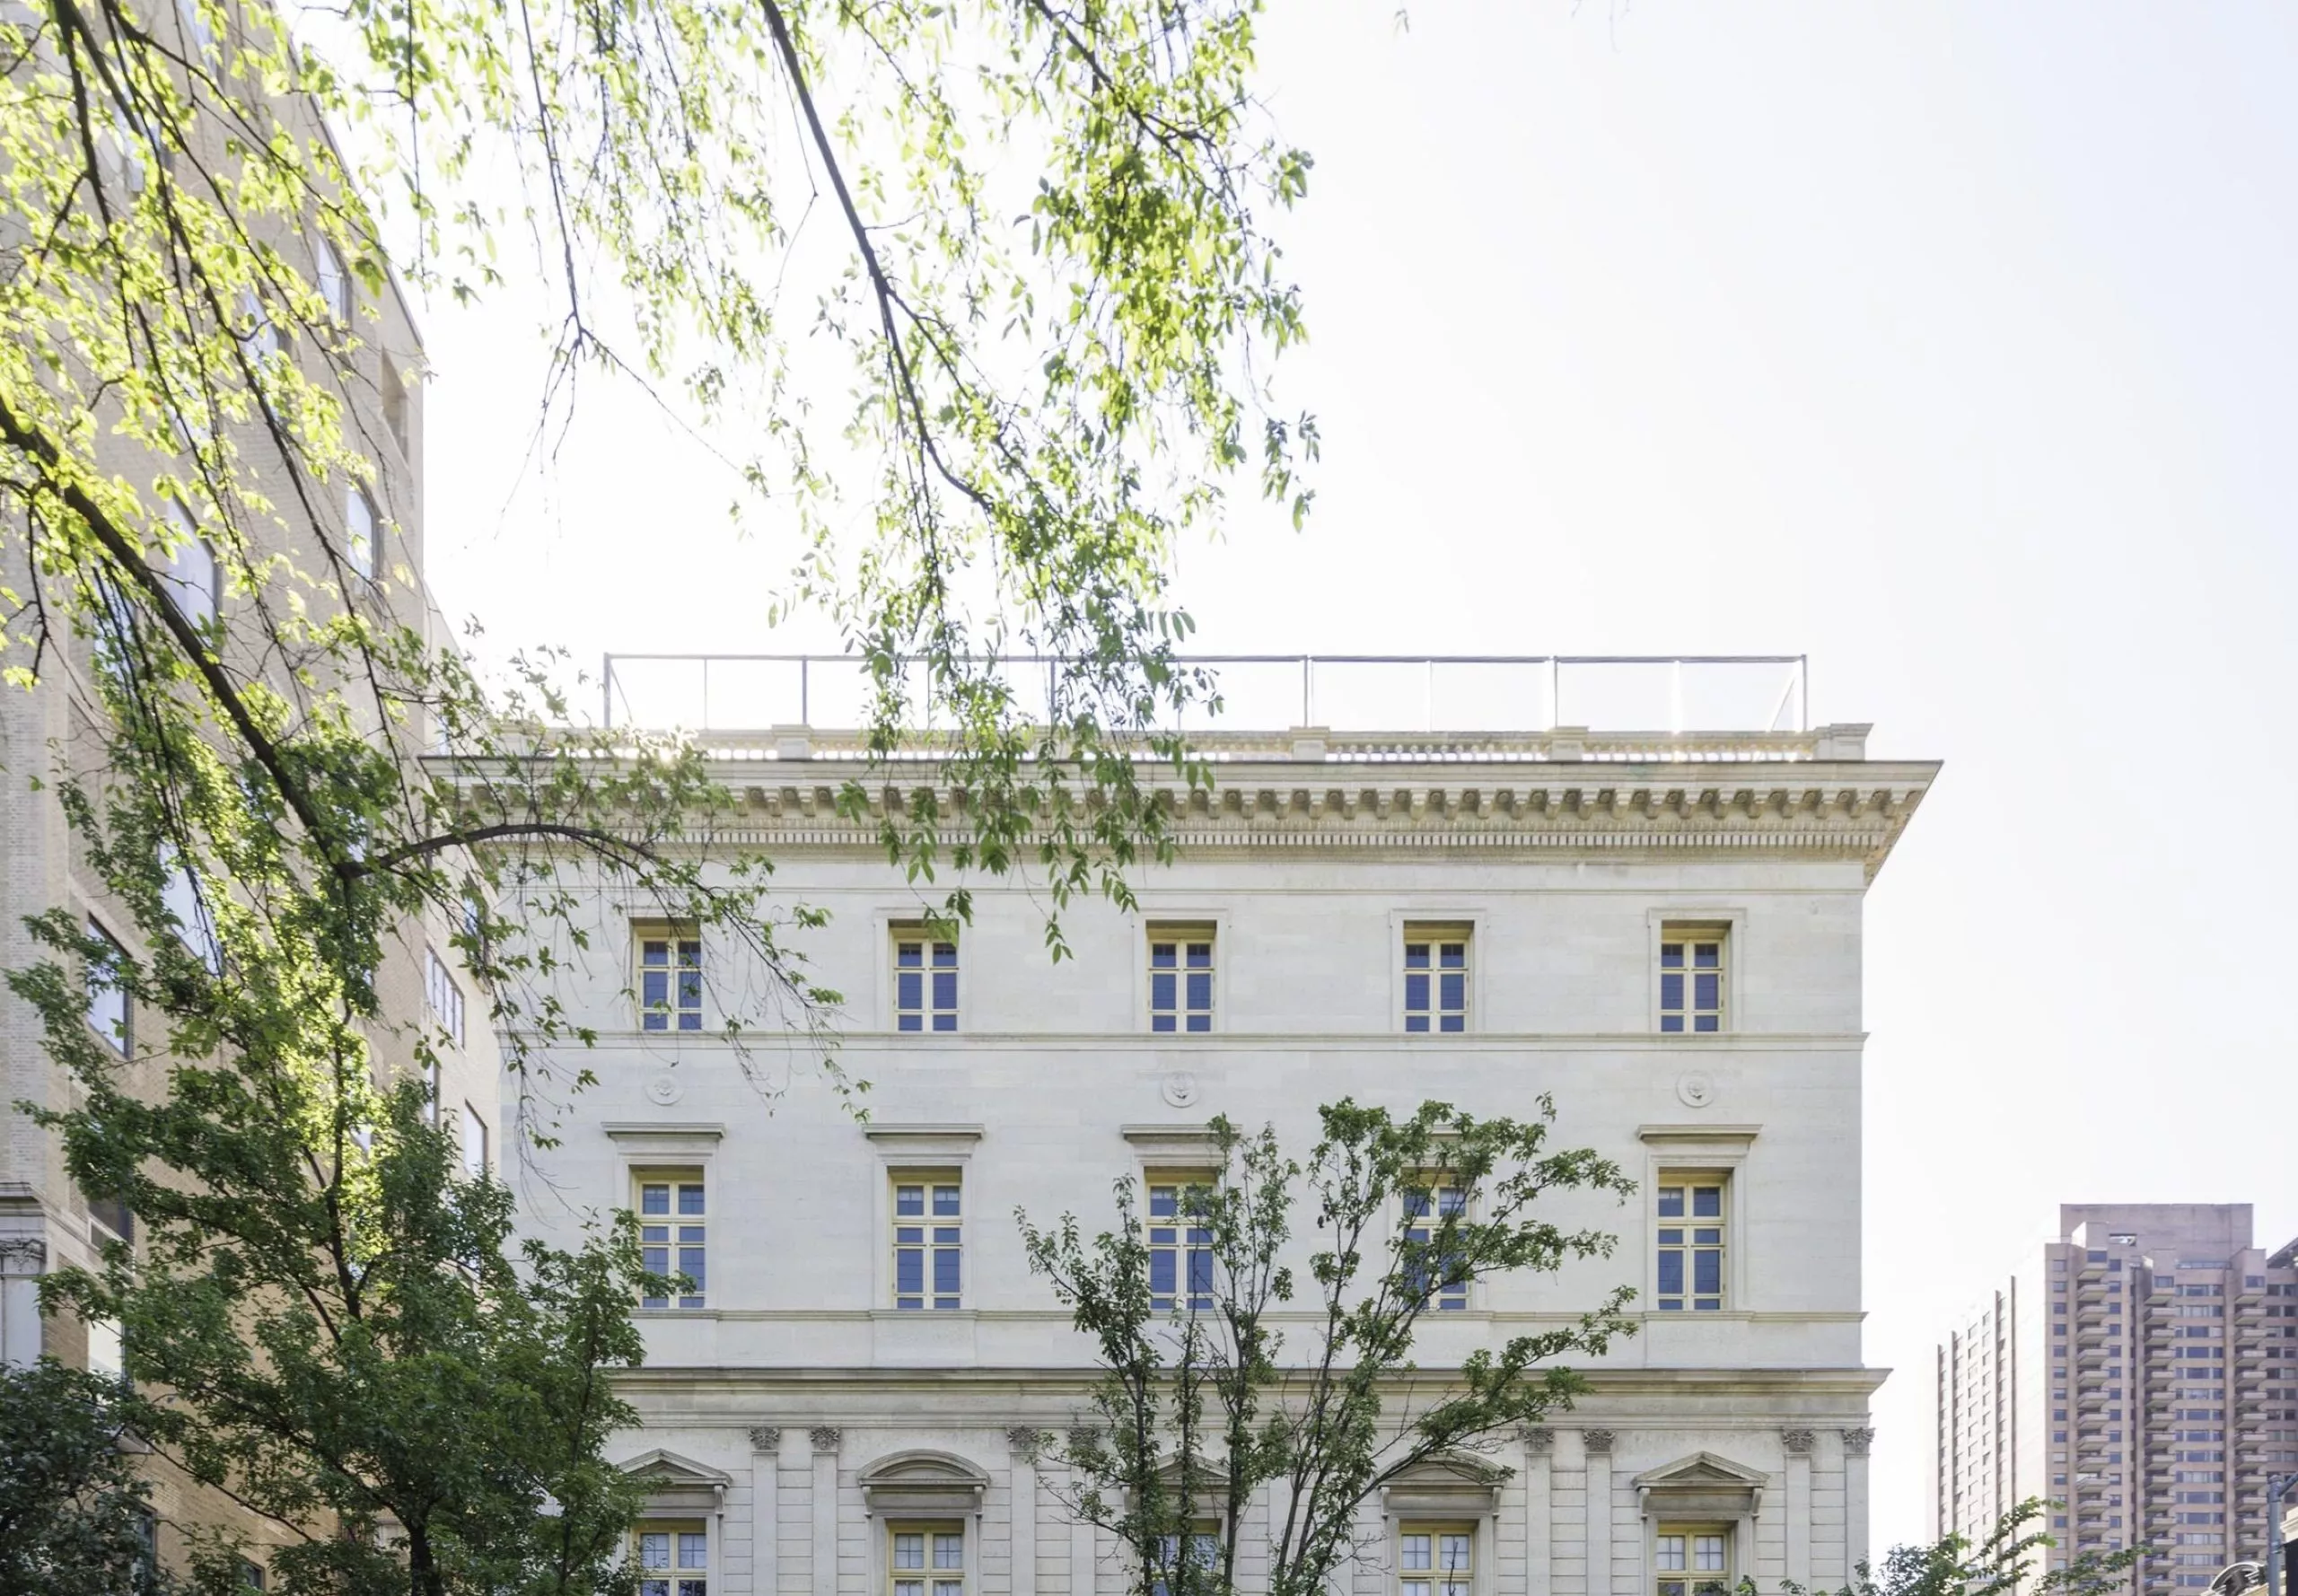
[505,706,1937,1596]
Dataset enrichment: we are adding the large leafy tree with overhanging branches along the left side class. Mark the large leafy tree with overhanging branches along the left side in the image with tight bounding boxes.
[0,0,1314,1593]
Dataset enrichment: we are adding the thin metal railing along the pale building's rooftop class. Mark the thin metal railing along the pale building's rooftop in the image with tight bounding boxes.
[602,654,1811,737]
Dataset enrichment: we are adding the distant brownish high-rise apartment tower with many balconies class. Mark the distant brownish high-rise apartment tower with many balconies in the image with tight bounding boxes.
[1928,1204,2298,1596]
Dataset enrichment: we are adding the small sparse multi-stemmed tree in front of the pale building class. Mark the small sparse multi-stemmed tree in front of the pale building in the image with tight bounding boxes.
[1021,1098,1636,1596]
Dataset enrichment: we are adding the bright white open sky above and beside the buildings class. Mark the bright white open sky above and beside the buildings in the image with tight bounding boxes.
[427,0,2298,1548]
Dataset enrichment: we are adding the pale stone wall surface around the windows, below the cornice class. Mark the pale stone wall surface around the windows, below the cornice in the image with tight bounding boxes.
[498,748,1928,1596]
